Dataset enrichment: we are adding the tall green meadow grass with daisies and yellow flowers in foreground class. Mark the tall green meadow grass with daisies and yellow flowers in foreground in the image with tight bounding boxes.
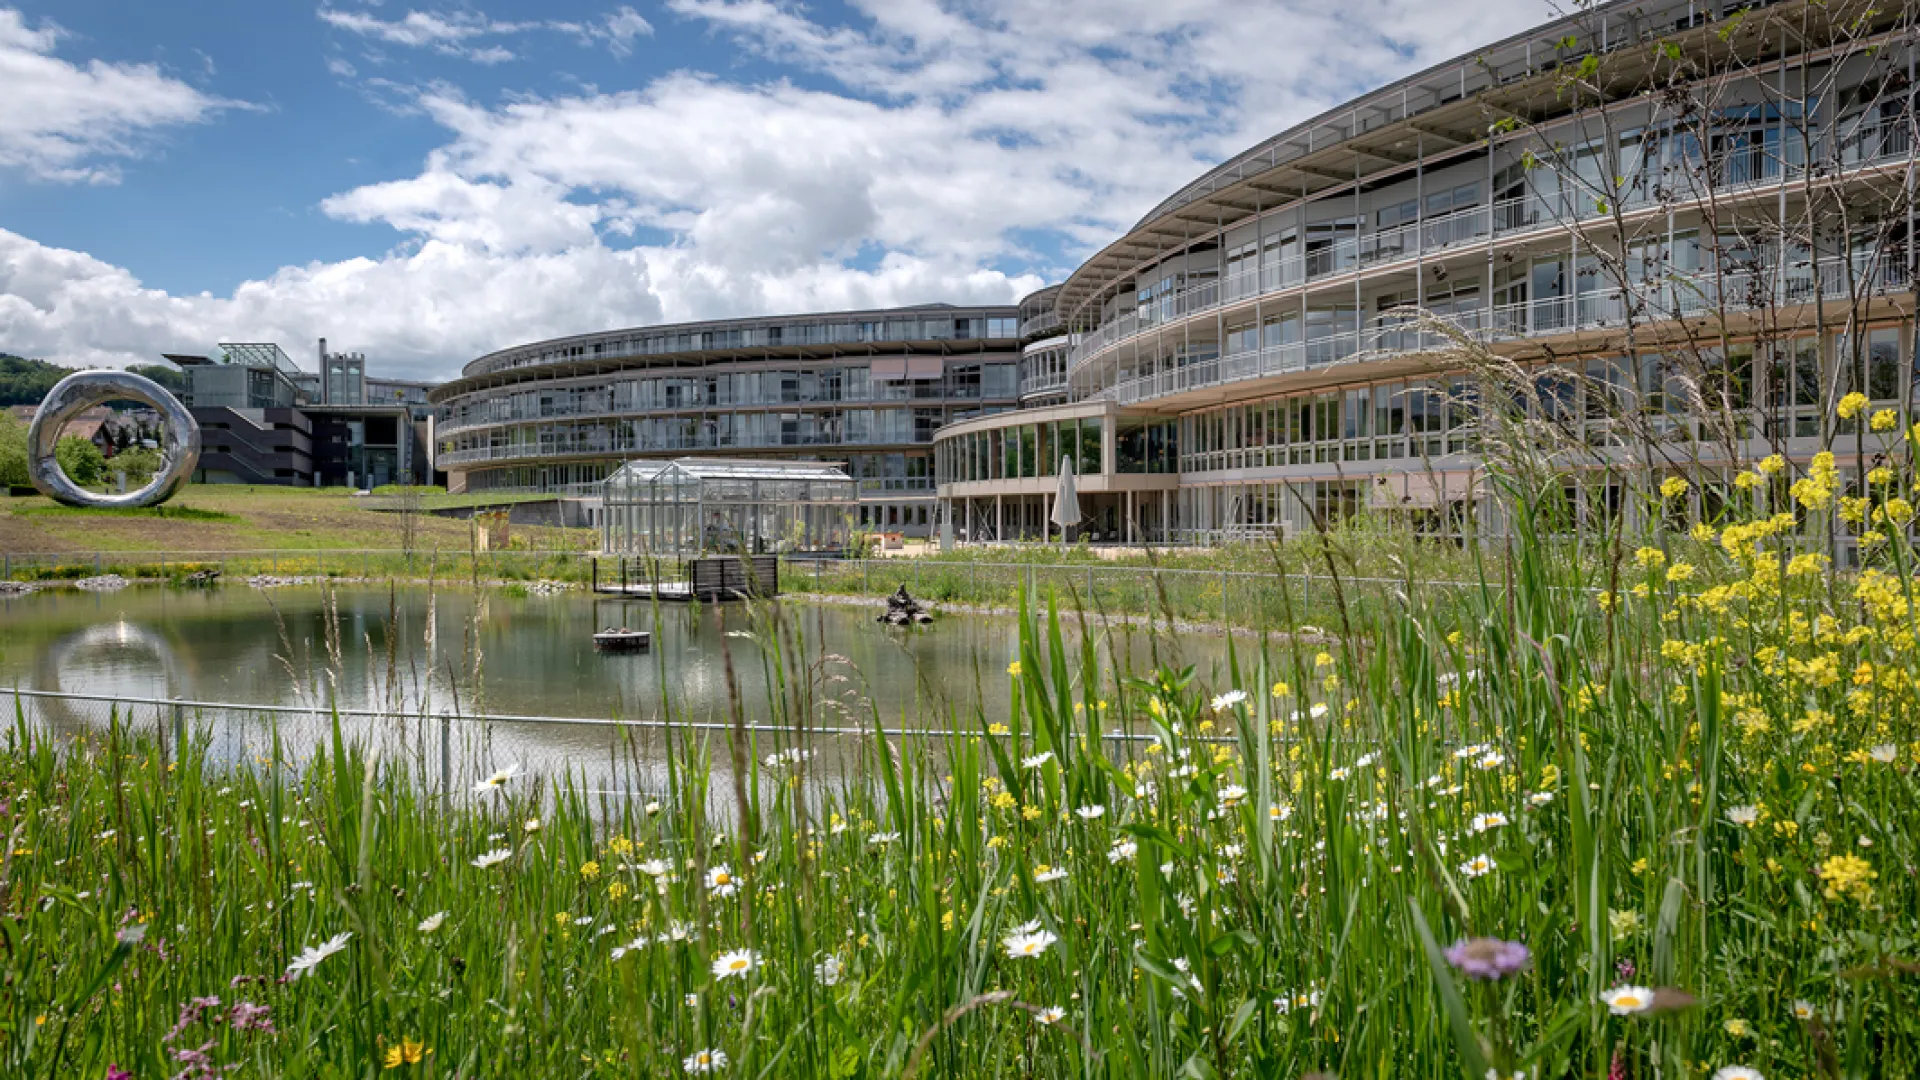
[0,440,1920,1080]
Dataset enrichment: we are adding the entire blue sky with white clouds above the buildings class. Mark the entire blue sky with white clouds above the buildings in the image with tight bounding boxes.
[0,0,1553,379]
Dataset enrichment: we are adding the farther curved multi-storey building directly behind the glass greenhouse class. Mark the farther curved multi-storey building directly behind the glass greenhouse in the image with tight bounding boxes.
[430,304,1021,534]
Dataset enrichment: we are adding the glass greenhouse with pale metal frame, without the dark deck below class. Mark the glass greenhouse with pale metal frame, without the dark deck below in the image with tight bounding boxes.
[601,457,858,557]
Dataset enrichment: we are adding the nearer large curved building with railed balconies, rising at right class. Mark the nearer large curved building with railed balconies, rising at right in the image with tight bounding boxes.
[935,0,1916,542]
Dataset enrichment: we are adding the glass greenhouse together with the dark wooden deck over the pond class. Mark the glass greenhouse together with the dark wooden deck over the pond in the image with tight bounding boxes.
[593,457,858,600]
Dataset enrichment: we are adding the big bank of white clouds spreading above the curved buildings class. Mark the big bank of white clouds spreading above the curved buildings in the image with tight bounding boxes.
[0,0,1549,377]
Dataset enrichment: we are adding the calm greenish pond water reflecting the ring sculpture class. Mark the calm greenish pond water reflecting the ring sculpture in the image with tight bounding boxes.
[0,586,1225,795]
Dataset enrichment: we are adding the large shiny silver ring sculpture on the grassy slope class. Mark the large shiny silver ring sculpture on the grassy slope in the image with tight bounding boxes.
[27,371,200,509]
